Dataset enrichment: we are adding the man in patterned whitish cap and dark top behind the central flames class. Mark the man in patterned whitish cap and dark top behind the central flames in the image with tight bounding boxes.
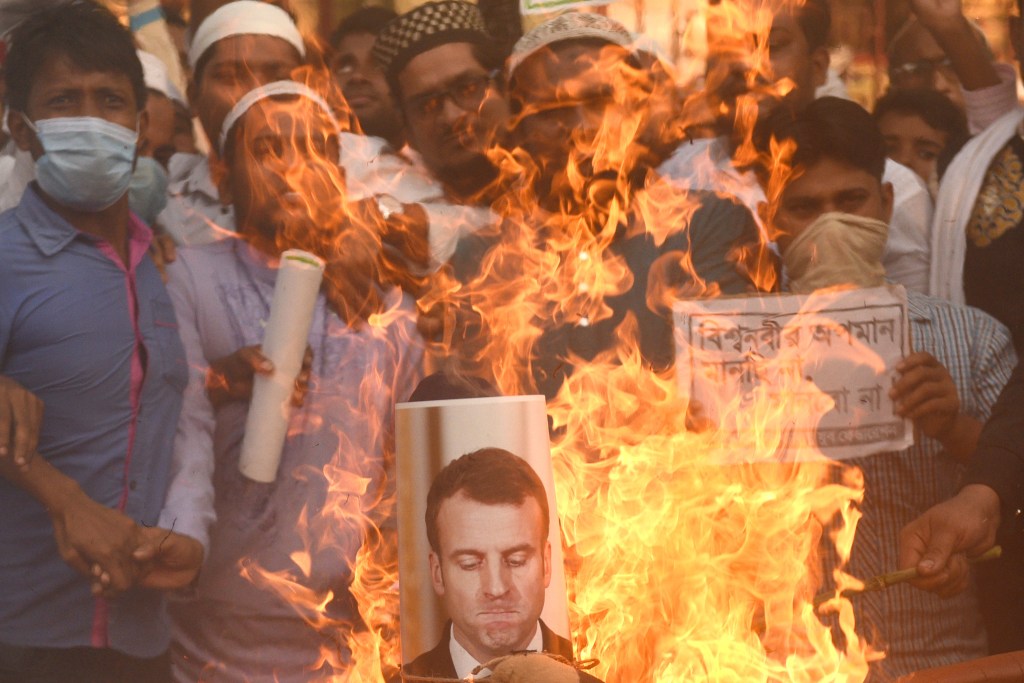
[452,12,760,398]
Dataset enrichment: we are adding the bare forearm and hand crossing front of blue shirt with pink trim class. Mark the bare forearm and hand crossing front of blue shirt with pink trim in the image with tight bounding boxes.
[0,450,143,592]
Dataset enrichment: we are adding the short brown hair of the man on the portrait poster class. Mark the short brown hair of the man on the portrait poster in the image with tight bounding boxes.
[424,449,551,555]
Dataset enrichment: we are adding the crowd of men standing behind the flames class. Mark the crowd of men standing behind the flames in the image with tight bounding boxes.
[0,0,1024,683]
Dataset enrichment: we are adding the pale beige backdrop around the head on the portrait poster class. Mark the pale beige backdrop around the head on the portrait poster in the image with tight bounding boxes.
[395,395,569,663]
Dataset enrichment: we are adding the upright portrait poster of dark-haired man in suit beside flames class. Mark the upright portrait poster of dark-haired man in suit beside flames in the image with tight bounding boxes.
[396,396,571,678]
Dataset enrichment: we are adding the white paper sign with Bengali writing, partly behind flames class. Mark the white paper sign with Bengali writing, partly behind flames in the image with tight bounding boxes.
[675,286,913,460]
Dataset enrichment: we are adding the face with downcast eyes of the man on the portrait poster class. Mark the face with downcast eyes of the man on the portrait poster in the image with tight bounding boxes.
[430,492,551,663]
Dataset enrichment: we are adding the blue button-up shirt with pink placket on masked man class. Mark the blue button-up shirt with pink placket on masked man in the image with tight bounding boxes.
[0,188,187,656]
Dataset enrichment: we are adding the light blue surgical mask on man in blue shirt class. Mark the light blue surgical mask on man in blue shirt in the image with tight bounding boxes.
[23,115,138,212]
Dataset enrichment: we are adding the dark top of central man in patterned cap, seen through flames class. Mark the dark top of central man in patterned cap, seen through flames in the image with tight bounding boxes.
[449,191,759,399]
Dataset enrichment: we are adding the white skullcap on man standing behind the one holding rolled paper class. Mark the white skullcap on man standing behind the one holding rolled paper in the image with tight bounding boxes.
[188,0,306,70]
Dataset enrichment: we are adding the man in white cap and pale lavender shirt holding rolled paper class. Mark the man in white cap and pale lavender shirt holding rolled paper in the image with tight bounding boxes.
[169,81,422,683]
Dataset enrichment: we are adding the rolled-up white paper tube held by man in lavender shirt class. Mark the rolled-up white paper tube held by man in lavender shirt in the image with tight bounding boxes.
[239,249,324,483]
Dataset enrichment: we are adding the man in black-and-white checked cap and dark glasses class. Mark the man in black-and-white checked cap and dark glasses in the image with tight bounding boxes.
[374,0,508,265]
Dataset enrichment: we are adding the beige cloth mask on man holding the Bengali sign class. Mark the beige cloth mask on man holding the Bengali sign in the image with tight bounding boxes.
[782,213,889,294]
